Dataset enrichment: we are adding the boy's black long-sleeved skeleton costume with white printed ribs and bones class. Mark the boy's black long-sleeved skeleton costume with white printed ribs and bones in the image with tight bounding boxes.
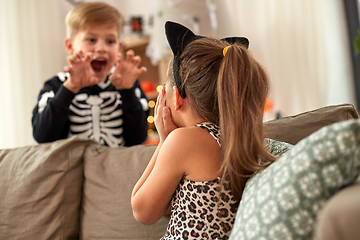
[32,72,149,147]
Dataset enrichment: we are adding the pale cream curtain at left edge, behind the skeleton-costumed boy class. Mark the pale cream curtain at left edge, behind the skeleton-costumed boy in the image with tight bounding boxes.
[0,0,66,149]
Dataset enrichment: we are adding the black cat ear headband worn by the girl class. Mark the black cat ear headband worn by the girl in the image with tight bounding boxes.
[165,21,249,98]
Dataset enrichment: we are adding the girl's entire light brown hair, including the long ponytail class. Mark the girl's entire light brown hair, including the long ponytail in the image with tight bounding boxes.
[170,38,275,201]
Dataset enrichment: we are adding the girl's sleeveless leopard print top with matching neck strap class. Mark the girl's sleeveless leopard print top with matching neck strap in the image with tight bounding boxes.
[161,123,238,240]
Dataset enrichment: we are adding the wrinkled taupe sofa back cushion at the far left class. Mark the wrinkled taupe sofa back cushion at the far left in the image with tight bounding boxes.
[0,137,93,240]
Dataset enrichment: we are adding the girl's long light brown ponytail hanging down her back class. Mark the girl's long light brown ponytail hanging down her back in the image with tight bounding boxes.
[217,44,275,201]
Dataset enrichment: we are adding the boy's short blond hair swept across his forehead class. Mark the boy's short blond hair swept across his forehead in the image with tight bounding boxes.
[65,2,124,38]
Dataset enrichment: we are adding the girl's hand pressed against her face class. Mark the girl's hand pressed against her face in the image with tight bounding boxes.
[154,87,177,143]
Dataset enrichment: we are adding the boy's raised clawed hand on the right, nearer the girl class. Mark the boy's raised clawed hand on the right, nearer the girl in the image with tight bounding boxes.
[109,50,147,90]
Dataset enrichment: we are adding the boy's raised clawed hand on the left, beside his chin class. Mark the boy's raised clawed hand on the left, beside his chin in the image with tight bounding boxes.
[64,52,99,93]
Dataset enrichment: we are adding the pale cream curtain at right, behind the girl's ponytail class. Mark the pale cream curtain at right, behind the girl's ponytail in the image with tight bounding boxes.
[227,0,356,115]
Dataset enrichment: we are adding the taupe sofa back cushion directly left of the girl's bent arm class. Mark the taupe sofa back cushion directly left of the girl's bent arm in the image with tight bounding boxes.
[81,145,169,240]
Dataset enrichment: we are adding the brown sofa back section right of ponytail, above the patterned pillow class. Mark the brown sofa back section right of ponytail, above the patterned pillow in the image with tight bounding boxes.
[264,104,359,145]
